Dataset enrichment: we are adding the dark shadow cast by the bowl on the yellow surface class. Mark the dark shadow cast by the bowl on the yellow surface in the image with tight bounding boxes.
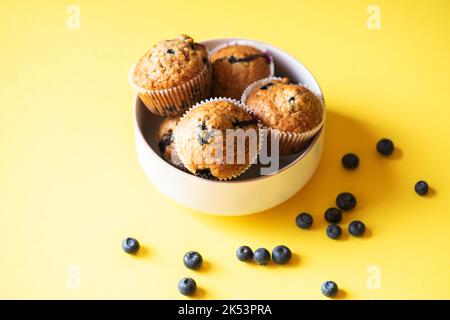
[188,107,400,229]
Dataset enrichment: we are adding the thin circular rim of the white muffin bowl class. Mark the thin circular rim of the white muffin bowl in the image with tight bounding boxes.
[133,38,325,185]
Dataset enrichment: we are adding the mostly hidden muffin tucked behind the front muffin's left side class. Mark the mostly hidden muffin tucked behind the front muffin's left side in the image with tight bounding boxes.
[156,116,184,169]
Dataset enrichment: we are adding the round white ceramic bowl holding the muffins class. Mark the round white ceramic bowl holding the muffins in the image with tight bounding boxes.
[133,39,324,216]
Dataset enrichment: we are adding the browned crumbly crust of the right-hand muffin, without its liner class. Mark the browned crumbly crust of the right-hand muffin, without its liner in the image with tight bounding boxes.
[246,78,323,133]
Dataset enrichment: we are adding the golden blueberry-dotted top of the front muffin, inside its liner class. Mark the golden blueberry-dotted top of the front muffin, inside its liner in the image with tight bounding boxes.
[175,99,259,180]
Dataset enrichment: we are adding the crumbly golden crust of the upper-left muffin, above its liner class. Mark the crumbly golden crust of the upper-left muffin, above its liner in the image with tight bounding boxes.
[133,35,209,90]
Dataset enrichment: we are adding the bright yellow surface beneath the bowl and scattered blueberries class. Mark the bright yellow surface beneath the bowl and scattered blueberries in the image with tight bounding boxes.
[0,0,450,299]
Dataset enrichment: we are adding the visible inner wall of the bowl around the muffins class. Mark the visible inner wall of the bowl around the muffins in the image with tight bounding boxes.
[136,39,323,181]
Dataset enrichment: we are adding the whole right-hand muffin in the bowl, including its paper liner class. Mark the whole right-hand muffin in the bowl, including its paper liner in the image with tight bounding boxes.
[242,78,325,155]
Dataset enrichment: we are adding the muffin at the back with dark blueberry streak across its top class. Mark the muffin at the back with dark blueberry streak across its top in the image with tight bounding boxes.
[211,44,274,99]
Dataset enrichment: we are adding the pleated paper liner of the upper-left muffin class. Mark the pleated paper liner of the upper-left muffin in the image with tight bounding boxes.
[128,62,212,116]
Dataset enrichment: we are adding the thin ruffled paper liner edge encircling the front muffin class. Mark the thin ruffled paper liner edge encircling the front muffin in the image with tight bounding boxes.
[174,97,262,181]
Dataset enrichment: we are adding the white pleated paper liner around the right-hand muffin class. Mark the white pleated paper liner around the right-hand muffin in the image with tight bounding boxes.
[241,77,326,155]
